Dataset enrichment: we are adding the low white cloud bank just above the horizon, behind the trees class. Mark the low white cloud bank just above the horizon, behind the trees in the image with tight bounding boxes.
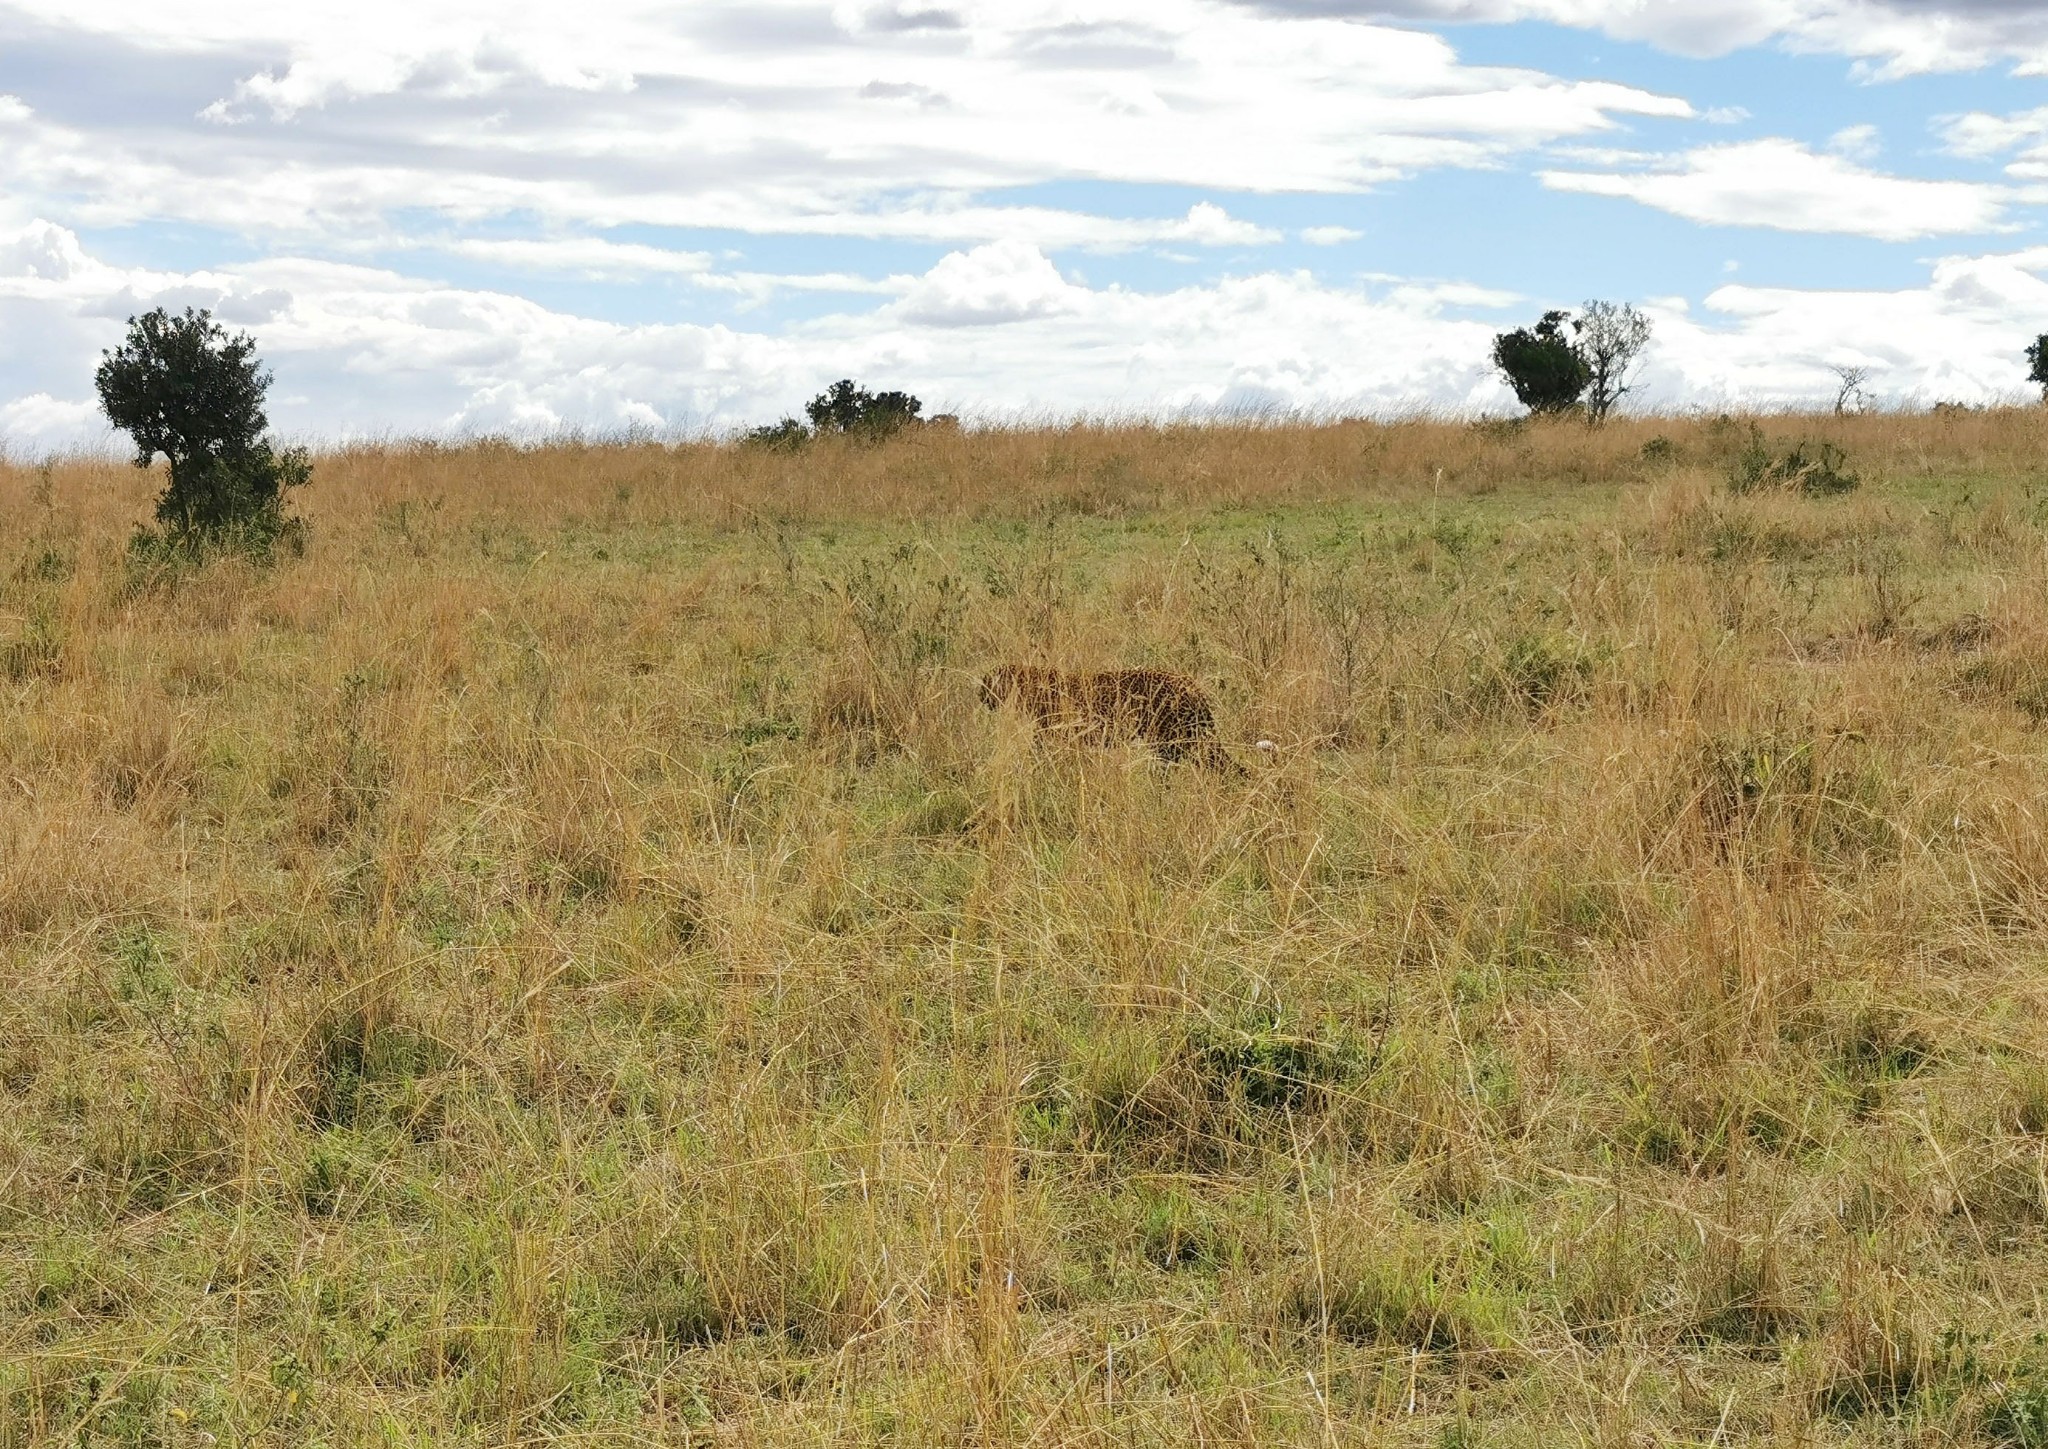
[0,218,2048,454]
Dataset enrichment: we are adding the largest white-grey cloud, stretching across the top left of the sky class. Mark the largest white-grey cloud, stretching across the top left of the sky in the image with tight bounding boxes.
[0,0,1692,246]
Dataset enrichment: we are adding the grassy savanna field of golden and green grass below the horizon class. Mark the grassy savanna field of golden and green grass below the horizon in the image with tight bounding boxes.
[19,409,2048,1449]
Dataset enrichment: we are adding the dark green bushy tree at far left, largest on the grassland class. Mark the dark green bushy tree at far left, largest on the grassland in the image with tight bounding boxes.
[92,307,313,548]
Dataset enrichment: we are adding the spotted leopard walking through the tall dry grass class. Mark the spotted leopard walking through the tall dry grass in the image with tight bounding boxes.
[981,663,1243,776]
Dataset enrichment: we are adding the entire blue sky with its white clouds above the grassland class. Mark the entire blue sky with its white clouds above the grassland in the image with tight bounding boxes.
[0,0,2048,454]
